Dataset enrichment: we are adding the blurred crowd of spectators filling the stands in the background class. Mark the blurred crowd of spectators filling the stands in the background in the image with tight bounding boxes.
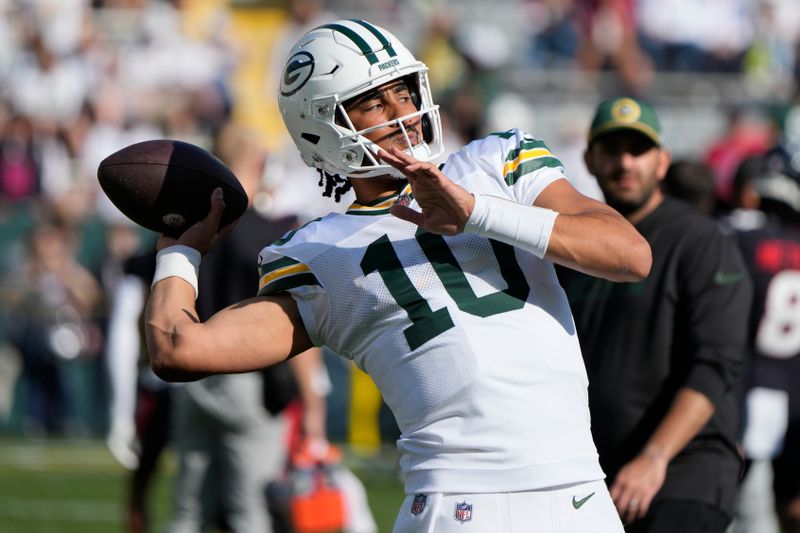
[0,0,800,528]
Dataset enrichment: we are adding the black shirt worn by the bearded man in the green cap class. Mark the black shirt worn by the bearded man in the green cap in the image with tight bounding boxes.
[558,198,752,512]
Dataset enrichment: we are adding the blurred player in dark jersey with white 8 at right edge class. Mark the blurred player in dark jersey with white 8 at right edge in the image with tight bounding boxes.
[727,146,800,533]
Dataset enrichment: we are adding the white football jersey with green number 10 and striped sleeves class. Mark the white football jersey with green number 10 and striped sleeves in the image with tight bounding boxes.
[259,130,603,494]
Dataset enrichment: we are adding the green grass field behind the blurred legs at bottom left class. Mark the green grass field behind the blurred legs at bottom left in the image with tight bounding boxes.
[0,438,403,533]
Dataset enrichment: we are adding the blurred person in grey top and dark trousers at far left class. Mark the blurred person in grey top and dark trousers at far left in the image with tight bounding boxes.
[4,214,101,435]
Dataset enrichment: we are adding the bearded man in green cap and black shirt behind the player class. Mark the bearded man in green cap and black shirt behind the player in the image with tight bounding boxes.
[559,97,752,533]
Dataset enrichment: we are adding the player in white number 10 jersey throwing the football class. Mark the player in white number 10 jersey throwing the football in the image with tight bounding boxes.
[147,20,652,533]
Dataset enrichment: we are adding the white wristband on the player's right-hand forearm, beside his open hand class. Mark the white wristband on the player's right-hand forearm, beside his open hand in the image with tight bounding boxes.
[464,194,558,257]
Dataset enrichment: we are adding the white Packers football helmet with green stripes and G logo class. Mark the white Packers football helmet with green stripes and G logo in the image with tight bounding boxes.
[278,19,444,178]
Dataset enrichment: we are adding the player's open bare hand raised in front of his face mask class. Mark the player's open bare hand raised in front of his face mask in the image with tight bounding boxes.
[380,147,475,235]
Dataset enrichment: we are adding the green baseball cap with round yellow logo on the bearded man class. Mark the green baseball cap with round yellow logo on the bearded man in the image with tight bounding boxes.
[589,96,661,146]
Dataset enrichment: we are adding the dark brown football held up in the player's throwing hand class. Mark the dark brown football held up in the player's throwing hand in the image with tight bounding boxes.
[97,139,248,237]
